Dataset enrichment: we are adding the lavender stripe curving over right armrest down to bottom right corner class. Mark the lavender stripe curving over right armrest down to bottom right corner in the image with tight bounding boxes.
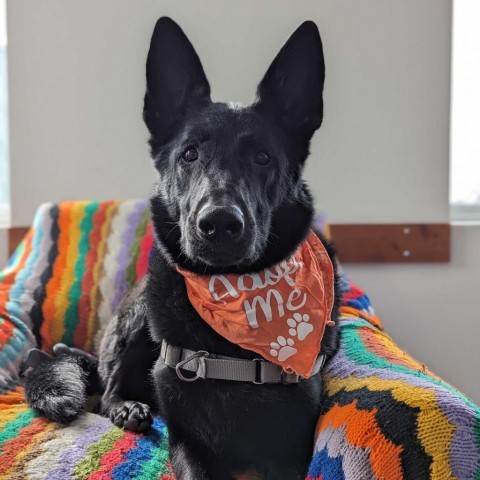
[325,348,480,478]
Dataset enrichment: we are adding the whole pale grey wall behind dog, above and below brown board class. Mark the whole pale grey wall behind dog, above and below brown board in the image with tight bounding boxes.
[4,0,480,402]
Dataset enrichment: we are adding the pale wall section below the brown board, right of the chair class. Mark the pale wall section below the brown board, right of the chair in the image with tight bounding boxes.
[346,226,480,404]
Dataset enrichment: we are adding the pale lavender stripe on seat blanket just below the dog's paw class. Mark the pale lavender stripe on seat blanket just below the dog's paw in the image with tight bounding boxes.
[48,417,113,480]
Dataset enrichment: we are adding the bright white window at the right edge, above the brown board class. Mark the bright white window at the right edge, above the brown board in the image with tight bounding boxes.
[450,0,480,221]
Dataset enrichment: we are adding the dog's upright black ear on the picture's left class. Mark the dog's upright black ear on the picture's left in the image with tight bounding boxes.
[143,17,210,141]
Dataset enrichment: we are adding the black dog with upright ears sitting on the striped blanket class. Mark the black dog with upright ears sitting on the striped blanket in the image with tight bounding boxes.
[26,18,338,480]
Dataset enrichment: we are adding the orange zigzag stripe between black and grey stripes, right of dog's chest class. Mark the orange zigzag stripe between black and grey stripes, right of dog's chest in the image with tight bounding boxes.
[316,401,403,480]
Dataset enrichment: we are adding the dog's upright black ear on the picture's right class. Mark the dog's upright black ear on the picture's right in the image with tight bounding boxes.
[257,21,325,138]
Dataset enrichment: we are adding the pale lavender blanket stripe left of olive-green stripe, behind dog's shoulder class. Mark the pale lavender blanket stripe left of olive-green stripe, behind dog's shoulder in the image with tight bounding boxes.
[112,202,147,312]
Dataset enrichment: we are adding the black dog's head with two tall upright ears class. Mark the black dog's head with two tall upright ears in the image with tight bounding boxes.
[144,18,325,273]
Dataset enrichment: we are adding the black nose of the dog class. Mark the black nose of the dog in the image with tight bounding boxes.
[197,207,245,242]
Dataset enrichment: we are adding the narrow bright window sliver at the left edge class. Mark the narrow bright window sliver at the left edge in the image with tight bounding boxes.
[0,0,10,225]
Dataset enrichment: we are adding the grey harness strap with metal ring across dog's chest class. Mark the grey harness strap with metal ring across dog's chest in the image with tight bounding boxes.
[160,340,326,385]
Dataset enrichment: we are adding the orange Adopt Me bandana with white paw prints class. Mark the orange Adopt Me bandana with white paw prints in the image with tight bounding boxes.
[178,232,334,378]
